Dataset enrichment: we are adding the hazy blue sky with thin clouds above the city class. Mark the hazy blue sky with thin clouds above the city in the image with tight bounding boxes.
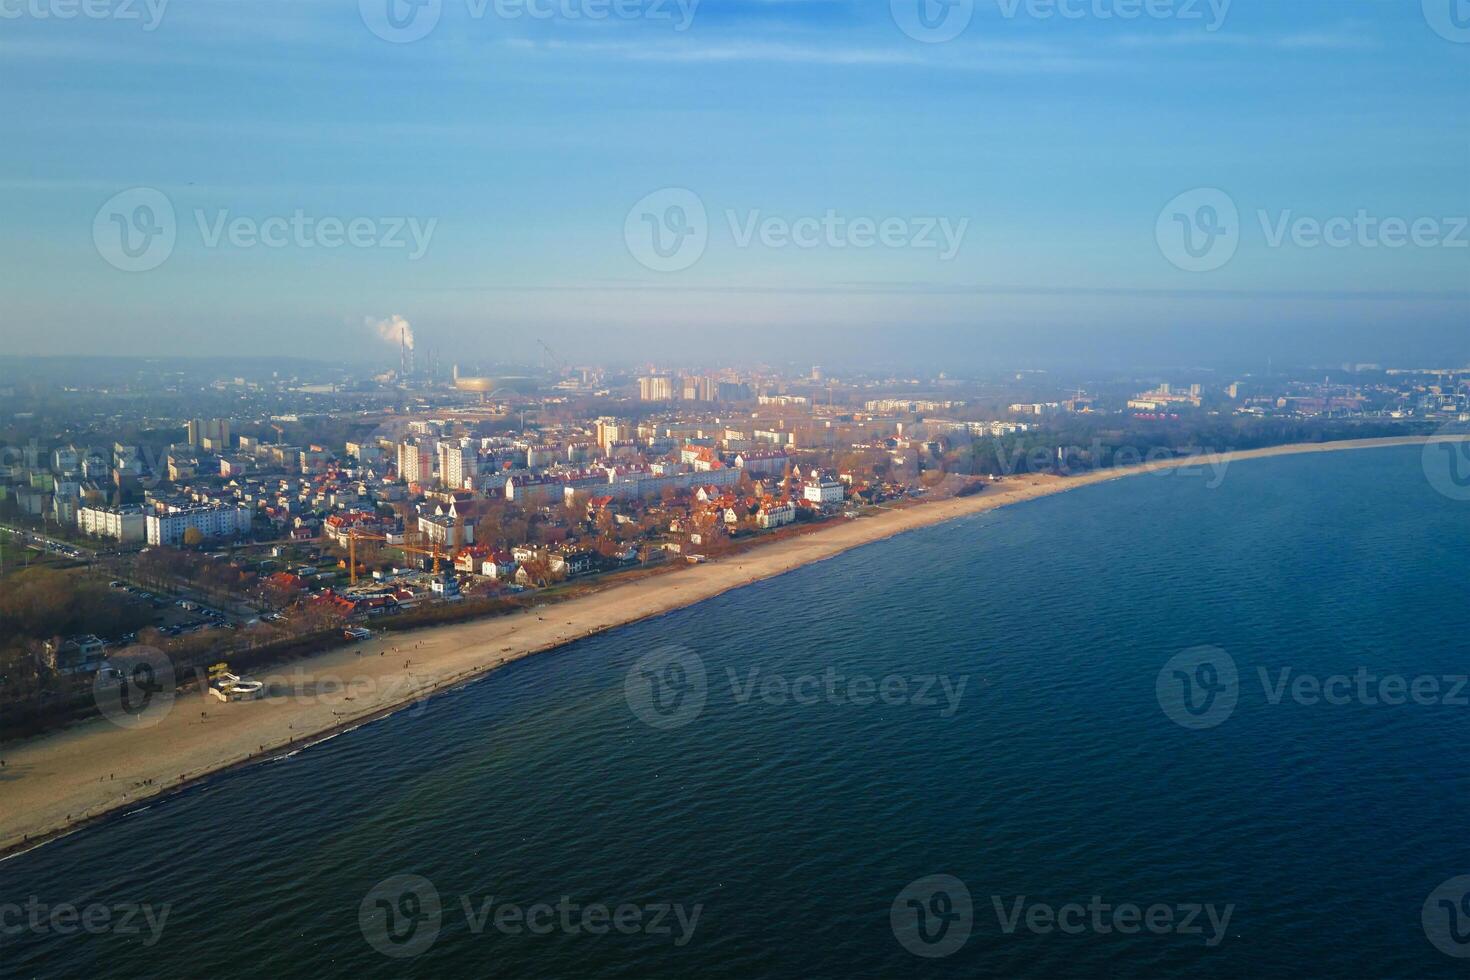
[0,0,1470,371]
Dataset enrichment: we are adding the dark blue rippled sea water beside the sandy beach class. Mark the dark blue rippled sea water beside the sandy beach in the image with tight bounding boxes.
[0,450,1470,979]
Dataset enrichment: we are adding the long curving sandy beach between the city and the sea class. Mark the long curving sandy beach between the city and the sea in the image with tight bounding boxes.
[0,436,1458,854]
